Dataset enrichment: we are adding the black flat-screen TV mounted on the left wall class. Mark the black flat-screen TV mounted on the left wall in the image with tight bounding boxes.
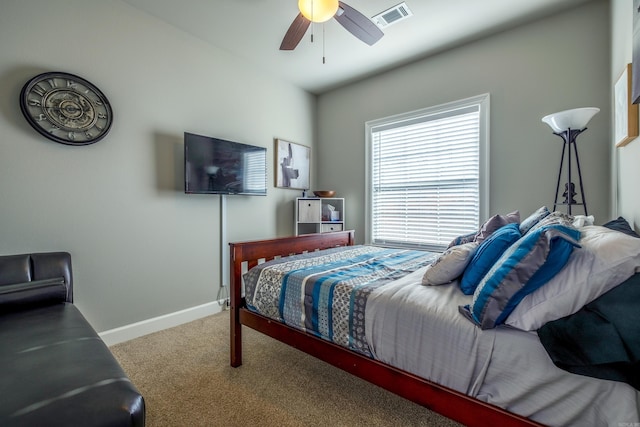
[184,132,267,196]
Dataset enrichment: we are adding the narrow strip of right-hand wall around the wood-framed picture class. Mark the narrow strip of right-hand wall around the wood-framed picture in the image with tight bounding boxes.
[610,0,640,230]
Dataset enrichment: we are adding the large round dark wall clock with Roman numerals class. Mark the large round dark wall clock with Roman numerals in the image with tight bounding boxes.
[20,72,113,145]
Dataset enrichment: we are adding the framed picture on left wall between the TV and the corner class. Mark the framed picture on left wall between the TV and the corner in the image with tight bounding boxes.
[275,139,311,190]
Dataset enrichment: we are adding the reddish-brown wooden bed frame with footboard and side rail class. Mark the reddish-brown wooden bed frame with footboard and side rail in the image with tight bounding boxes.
[230,230,541,426]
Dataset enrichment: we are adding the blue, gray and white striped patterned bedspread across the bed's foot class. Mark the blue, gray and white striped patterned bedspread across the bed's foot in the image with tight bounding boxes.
[244,245,437,357]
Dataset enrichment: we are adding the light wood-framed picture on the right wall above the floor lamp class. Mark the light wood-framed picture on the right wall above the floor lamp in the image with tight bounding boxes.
[613,64,638,147]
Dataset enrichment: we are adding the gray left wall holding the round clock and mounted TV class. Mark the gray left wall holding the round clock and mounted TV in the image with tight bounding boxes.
[0,0,315,331]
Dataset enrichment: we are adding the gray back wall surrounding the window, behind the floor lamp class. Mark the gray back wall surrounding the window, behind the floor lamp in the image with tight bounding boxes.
[317,1,610,241]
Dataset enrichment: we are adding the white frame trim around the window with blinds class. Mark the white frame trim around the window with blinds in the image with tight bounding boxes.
[365,93,490,251]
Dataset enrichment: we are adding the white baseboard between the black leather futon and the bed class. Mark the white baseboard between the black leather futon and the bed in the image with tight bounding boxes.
[98,300,225,346]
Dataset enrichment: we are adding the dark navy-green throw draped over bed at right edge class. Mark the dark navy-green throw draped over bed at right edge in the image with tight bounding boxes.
[538,273,640,390]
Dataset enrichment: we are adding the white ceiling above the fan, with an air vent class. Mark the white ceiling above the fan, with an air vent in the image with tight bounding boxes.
[124,0,591,93]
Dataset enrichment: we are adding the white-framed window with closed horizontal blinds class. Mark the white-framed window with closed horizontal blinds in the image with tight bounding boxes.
[366,94,489,250]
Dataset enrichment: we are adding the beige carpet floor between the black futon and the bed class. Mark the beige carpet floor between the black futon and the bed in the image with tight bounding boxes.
[111,312,458,427]
